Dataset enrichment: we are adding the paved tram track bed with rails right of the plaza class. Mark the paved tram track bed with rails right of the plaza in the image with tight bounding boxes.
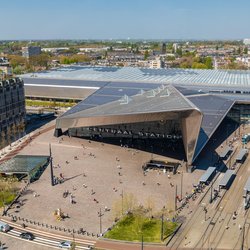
[169,138,250,249]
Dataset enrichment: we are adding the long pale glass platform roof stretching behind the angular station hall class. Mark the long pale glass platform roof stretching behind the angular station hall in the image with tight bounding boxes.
[22,65,250,86]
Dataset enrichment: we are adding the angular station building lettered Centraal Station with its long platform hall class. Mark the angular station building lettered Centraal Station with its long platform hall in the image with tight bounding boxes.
[20,65,250,165]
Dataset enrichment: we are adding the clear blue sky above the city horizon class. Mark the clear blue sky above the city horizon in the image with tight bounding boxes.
[0,0,250,40]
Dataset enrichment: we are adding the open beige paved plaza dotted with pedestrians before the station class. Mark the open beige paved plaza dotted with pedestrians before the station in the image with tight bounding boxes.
[5,121,203,236]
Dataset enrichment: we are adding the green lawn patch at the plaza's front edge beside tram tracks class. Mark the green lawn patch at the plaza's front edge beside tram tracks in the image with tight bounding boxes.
[104,215,178,243]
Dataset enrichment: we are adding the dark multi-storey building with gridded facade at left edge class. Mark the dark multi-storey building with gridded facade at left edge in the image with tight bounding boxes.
[0,78,25,148]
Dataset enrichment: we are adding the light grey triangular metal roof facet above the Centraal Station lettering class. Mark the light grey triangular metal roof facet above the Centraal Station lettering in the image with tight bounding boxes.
[64,85,196,118]
